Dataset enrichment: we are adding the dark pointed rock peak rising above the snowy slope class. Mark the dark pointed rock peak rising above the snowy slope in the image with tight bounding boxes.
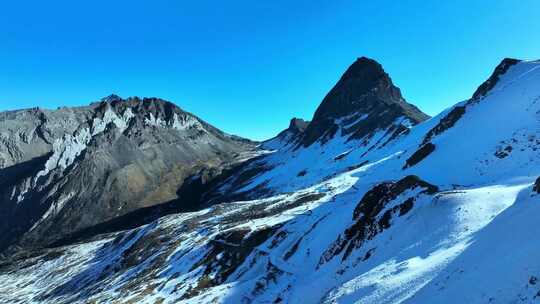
[302,57,429,146]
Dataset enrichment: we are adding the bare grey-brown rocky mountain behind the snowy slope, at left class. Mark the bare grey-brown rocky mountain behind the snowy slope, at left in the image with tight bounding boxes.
[0,95,254,251]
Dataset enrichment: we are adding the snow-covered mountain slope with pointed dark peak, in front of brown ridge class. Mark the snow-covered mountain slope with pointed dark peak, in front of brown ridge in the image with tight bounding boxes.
[0,58,540,303]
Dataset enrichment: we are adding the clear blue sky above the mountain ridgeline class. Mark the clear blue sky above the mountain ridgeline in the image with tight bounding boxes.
[0,0,540,139]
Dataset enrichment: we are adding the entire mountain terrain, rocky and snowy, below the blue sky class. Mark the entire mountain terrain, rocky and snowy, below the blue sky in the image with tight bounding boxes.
[0,57,540,304]
